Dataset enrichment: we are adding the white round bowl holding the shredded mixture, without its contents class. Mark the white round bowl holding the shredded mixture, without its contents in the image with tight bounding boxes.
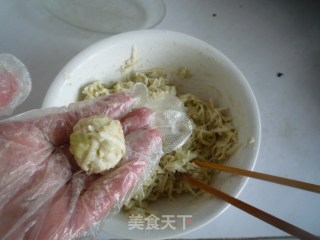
[43,30,260,239]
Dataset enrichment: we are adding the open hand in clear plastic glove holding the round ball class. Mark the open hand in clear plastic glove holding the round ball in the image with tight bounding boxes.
[0,92,162,240]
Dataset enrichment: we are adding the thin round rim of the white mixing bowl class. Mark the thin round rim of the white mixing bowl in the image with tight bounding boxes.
[42,29,261,239]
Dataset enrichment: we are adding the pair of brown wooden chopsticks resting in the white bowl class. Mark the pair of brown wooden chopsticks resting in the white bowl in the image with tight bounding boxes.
[182,159,320,240]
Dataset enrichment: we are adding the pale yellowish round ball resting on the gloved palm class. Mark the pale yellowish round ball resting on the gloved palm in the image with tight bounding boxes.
[70,116,126,174]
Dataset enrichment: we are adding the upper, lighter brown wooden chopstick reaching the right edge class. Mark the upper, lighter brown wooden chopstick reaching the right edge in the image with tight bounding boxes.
[193,159,320,193]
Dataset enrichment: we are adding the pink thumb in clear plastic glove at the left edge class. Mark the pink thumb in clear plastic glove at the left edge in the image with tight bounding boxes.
[0,54,32,116]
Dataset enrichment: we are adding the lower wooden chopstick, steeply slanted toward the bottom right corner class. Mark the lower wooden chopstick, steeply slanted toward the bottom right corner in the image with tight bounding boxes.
[182,174,320,240]
